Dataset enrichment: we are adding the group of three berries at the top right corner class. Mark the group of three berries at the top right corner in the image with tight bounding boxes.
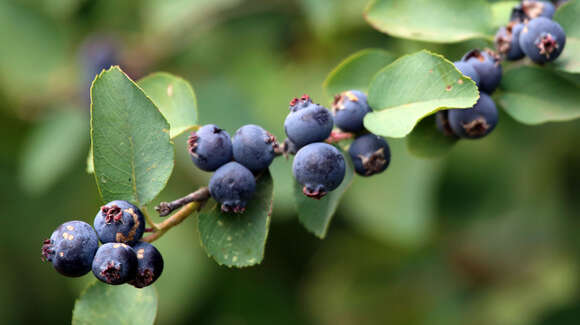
[495,0,566,64]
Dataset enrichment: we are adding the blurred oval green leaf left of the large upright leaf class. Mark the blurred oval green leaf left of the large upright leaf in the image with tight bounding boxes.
[19,107,89,194]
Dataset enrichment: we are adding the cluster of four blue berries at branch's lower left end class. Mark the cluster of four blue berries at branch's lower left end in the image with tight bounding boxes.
[42,201,163,288]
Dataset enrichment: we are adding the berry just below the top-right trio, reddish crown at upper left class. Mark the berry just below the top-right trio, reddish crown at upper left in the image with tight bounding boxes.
[462,50,502,94]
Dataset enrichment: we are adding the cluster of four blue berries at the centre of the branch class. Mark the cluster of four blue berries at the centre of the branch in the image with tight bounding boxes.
[284,90,391,199]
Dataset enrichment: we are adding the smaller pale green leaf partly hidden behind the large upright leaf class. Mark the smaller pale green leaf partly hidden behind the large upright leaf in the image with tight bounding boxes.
[138,72,197,139]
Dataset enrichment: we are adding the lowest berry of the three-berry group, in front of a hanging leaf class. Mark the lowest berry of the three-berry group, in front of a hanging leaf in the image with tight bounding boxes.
[209,161,256,213]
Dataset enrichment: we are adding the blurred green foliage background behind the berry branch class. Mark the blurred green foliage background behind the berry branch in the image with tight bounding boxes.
[0,0,580,325]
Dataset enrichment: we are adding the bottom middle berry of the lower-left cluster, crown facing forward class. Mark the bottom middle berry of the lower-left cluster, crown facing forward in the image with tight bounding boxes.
[93,243,137,285]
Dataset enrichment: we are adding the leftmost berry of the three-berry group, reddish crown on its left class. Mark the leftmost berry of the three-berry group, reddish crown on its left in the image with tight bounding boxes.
[187,124,233,172]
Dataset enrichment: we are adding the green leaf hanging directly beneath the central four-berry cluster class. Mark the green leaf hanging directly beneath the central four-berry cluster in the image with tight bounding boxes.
[294,151,354,239]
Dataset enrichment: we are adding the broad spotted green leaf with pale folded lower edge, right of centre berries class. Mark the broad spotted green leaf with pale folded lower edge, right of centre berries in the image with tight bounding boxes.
[364,50,479,138]
